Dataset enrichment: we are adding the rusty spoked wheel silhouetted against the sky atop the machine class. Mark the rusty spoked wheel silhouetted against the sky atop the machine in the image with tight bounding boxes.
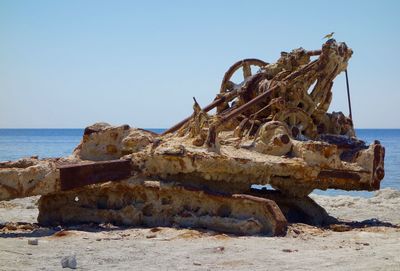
[220,58,268,94]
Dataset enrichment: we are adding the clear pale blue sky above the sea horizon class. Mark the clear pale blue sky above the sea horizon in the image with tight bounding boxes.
[0,0,400,128]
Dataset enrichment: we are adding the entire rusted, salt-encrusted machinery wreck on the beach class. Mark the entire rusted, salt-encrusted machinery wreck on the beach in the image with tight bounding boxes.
[0,39,385,235]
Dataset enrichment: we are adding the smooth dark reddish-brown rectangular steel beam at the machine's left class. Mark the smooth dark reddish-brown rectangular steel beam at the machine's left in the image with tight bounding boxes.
[57,160,133,190]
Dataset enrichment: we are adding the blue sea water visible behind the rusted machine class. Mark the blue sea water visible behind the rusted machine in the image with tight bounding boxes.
[0,129,400,197]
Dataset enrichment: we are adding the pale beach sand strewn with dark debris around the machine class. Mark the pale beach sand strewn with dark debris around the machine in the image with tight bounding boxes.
[0,189,400,270]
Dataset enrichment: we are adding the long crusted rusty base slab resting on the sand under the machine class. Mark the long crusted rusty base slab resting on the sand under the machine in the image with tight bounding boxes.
[38,181,287,235]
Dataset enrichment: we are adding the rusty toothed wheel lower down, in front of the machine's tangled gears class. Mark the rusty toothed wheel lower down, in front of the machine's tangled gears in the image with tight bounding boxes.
[274,108,317,140]
